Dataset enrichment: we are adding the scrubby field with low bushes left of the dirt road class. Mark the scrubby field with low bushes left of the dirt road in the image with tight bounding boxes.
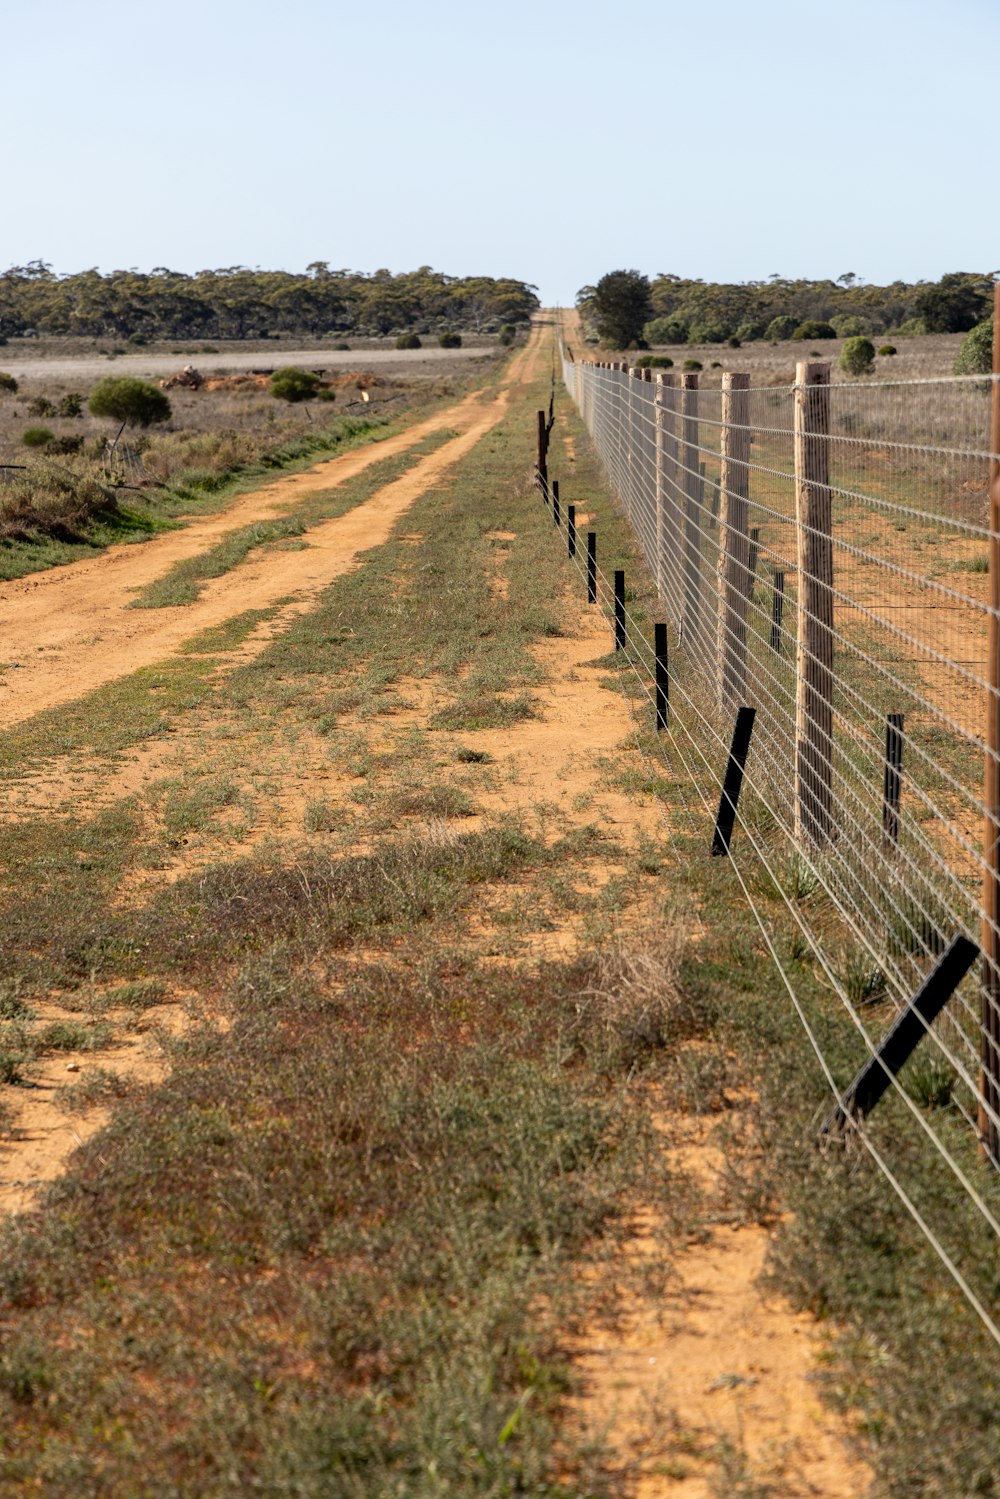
[0,351,492,579]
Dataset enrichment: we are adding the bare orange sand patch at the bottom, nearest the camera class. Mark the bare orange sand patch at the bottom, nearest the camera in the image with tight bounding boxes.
[576,1112,871,1499]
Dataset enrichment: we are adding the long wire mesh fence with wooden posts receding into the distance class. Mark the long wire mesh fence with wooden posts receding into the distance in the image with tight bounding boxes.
[562,347,1000,1337]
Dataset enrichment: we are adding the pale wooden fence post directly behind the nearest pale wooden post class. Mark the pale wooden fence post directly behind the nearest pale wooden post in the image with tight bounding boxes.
[717,373,750,708]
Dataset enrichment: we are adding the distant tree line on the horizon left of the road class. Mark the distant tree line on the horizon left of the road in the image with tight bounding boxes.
[0,261,538,342]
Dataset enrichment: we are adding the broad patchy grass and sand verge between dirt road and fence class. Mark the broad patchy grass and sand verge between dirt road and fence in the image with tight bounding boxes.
[0,319,1000,1499]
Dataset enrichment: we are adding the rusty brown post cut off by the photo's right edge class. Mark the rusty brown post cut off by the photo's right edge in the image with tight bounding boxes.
[979,282,1000,1165]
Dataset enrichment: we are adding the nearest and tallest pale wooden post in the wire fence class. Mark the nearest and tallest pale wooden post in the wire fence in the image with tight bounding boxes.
[795,363,834,844]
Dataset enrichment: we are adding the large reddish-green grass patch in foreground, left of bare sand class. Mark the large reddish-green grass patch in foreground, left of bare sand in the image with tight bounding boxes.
[0,950,680,1499]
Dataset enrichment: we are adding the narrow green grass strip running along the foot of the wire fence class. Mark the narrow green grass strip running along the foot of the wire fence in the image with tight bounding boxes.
[538,347,1000,1499]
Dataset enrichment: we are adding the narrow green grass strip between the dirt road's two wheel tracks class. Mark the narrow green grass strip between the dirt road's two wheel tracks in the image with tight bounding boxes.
[129,427,457,609]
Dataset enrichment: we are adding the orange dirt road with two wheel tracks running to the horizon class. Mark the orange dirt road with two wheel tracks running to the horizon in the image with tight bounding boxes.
[0,330,541,724]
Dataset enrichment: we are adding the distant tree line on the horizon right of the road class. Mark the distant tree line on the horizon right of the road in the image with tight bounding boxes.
[577,270,993,348]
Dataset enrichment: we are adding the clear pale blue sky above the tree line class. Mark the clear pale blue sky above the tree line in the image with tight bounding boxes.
[0,0,1000,303]
